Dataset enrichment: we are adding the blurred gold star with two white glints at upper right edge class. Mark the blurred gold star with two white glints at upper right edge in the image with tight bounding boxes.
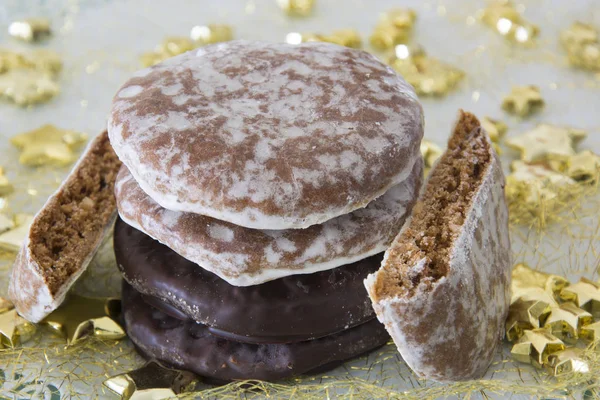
[481,0,539,45]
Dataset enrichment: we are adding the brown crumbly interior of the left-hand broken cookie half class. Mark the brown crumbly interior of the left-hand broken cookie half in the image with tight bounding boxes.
[30,132,121,293]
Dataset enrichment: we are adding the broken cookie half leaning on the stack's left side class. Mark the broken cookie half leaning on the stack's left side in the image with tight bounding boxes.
[9,132,121,321]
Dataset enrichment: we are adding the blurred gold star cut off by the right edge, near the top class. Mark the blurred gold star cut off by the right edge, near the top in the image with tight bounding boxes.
[560,22,600,71]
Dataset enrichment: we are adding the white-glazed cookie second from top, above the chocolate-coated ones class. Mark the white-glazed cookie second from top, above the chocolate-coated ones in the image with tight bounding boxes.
[115,158,423,286]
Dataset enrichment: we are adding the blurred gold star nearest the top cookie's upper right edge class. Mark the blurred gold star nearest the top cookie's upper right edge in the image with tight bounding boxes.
[389,44,465,96]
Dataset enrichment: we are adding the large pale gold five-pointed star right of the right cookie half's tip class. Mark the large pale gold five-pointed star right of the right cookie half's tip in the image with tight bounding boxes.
[506,124,587,162]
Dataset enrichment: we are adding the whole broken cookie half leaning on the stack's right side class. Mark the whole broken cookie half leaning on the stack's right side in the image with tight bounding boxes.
[365,111,512,381]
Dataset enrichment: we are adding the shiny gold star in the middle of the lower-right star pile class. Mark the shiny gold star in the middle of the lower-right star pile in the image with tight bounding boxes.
[544,302,594,343]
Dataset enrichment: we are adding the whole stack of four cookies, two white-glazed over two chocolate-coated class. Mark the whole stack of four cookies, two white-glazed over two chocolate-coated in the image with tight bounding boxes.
[108,41,423,381]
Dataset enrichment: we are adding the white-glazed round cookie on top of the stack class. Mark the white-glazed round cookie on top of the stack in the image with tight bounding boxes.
[108,41,423,230]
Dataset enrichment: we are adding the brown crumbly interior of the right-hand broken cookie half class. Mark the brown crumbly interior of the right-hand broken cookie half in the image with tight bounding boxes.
[374,112,492,298]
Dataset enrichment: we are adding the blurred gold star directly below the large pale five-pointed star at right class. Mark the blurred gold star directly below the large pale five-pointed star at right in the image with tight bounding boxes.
[506,161,577,205]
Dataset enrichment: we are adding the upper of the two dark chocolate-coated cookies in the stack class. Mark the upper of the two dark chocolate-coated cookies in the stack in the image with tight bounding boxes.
[114,220,382,343]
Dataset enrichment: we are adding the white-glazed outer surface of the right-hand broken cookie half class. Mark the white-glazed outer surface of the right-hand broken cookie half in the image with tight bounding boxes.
[365,141,512,381]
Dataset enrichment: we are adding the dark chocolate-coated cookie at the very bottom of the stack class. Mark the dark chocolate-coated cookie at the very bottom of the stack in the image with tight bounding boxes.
[122,283,389,381]
